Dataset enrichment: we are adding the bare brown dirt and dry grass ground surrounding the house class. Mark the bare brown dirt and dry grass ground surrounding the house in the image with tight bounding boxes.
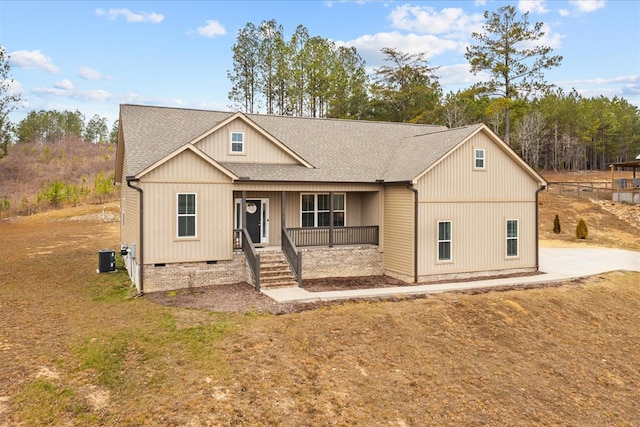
[0,171,640,426]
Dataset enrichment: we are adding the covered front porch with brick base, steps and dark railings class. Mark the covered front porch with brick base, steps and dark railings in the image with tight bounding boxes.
[233,190,382,291]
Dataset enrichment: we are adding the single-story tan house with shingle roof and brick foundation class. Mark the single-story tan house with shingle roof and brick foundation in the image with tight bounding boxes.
[115,105,546,292]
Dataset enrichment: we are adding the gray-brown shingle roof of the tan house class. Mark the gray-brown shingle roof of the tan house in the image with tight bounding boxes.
[120,105,481,182]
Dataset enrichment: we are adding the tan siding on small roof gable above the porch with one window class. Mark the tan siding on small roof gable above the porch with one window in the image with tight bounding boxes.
[196,119,298,164]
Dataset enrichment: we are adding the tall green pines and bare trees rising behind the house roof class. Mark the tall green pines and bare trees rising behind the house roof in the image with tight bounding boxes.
[228,6,640,170]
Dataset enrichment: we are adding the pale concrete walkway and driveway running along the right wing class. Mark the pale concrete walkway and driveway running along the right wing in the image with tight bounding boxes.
[262,248,640,302]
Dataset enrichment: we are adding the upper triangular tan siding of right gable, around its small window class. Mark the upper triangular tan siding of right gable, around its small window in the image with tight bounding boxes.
[417,133,537,201]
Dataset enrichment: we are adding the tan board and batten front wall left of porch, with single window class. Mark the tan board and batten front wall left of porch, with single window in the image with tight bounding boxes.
[138,150,233,264]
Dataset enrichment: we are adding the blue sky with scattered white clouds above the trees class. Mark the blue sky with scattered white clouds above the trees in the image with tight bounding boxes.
[0,0,640,126]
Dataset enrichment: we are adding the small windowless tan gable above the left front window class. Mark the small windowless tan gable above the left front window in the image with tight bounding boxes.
[142,149,232,183]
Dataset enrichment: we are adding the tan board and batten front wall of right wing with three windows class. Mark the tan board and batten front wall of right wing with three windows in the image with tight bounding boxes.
[416,132,540,276]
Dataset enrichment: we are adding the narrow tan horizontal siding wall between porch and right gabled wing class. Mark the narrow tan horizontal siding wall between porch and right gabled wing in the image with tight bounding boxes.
[383,187,414,276]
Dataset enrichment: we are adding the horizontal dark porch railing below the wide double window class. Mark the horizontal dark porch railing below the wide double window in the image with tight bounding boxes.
[287,225,380,247]
